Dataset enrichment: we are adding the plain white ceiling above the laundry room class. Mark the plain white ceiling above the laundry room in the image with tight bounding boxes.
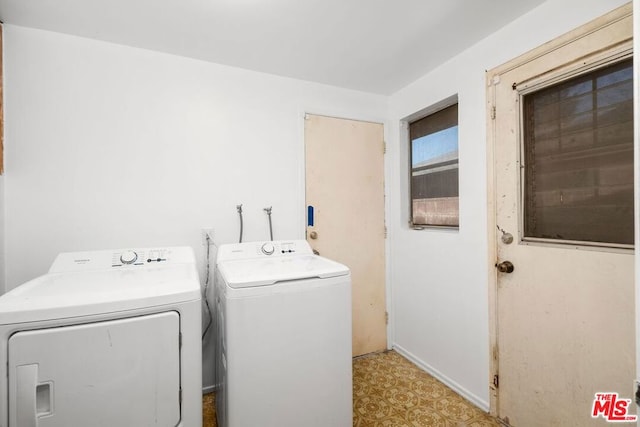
[0,0,544,95]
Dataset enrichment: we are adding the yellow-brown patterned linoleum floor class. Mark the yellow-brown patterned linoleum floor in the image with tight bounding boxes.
[202,351,500,427]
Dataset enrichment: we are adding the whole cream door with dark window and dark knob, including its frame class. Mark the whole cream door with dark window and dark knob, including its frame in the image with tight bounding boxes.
[488,5,635,427]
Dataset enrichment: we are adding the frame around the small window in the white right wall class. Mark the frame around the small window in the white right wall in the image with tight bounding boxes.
[401,94,460,232]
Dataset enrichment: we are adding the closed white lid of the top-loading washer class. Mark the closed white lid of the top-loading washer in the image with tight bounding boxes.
[218,255,349,288]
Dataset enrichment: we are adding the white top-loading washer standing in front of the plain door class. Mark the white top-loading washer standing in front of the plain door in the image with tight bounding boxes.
[215,240,353,427]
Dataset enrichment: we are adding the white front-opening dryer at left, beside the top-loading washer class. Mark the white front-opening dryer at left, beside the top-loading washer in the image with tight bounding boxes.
[0,247,202,427]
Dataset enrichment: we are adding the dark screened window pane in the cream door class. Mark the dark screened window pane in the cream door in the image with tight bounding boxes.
[523,59,634,245]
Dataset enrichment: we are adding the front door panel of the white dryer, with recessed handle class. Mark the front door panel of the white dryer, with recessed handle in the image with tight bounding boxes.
[8,311,180,427]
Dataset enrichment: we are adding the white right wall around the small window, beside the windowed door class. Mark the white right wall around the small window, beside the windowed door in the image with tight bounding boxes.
[388,0,625,409]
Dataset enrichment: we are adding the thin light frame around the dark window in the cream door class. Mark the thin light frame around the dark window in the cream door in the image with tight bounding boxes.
[513,51,637,252]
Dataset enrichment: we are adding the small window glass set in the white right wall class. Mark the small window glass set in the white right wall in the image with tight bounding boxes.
[409,104,459,227]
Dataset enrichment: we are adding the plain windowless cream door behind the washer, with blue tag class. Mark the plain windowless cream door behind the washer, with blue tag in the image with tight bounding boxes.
[305,114,387,356]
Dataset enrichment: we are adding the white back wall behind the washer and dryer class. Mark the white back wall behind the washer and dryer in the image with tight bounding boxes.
[4,25,386,385]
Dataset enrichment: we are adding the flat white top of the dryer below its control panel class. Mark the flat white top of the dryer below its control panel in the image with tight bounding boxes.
[0,251,201,324]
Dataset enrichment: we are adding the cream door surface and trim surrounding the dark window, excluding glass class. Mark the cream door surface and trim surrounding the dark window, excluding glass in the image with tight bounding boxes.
[488,6,635,427]
